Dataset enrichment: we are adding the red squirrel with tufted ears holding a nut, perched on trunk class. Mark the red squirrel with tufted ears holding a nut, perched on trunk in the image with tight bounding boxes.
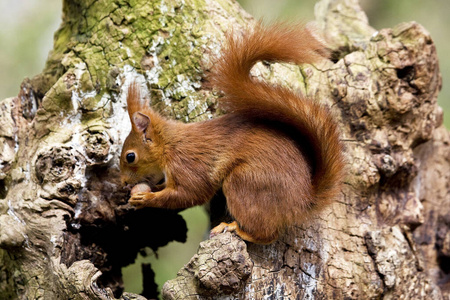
[120,24,344,244]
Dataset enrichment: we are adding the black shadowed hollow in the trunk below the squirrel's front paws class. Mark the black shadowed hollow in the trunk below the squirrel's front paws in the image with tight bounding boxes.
[61,208,187,298]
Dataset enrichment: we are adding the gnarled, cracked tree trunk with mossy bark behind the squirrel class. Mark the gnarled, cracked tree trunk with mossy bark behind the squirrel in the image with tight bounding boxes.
[0,0,450,299]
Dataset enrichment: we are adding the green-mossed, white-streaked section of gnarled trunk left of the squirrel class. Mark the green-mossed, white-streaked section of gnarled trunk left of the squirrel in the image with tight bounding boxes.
[0,0,253,299]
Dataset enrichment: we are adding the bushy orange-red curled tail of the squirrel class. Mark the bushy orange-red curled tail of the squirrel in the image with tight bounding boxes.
[208,24,344,209]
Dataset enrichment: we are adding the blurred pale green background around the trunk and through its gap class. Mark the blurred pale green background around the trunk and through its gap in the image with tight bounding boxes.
[0,0,450,293]
